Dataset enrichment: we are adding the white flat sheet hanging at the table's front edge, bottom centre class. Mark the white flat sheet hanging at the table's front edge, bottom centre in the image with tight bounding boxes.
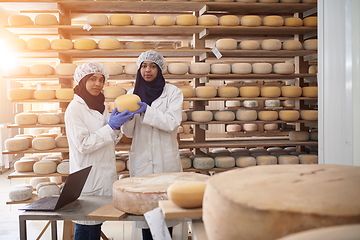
[144,208,171,240]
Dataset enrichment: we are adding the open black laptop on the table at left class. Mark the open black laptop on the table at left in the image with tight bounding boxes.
[19,166,92,211]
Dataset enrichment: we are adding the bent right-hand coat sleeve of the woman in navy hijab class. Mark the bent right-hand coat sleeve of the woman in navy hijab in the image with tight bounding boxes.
[142,88,184,132]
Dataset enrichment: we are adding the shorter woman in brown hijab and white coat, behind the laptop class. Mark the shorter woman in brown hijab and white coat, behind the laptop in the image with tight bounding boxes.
[65,62,135,240]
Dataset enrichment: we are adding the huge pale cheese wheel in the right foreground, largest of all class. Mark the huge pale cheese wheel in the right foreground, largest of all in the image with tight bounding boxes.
[202,164,360,240]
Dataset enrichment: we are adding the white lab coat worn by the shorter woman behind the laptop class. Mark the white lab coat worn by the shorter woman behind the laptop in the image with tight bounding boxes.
[65,94,122,225]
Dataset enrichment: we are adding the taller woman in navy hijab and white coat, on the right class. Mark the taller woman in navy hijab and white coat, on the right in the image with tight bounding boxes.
[122,50,183,239]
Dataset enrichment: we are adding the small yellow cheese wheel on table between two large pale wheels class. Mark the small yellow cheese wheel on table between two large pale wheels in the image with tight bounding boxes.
[167,181,206,208]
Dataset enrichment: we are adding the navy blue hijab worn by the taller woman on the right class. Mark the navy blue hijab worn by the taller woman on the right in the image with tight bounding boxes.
[134,63,165,106]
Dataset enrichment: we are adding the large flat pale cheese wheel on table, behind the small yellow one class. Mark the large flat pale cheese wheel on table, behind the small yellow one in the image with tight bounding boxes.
[113,172,209,215]
